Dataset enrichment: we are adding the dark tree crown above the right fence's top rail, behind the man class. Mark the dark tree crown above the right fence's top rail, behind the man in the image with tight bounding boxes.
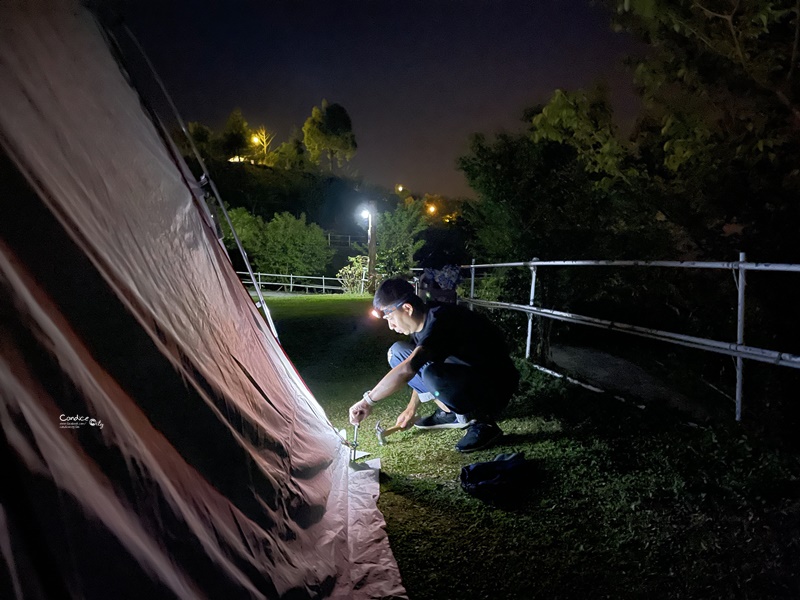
[459,134,658,261]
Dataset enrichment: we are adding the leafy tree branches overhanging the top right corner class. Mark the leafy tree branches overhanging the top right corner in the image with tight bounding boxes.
[607,0,800,126]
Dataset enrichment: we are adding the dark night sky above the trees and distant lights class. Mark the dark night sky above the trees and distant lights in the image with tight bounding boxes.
[126,0,636,196]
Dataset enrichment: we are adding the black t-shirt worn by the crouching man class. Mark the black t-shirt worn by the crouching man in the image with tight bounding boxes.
[411,303,515,372]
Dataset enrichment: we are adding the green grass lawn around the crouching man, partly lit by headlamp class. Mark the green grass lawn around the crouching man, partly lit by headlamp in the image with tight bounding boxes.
[267,296,800,600]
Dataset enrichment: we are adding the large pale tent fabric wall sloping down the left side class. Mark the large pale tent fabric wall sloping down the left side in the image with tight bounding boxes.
[0,0,405,600]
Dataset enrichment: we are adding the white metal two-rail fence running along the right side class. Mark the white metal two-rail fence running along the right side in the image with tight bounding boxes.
[450,253,800,421]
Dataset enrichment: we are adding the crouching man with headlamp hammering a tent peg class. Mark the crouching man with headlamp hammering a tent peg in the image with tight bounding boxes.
[350,278,519,452]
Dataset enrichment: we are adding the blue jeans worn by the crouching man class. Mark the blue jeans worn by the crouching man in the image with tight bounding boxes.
[389,342,519,420]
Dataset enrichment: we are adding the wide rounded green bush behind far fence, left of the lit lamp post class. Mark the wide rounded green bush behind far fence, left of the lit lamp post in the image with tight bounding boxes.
[258,212,334,275]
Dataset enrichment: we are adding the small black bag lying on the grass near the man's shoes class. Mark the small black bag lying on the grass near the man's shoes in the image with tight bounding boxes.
[461,452,535,504]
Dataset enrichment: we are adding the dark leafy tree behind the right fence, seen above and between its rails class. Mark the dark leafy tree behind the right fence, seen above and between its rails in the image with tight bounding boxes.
[459,132,672,359]
